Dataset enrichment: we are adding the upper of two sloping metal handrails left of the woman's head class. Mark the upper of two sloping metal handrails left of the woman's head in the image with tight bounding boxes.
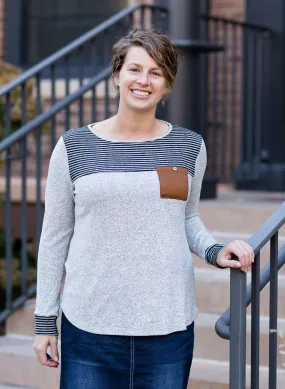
[0,3,167,98]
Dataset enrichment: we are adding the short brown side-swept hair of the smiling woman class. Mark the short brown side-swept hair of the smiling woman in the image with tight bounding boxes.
[111,28,178,89]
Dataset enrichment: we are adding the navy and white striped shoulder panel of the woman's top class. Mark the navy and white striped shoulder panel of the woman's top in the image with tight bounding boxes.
[63,126,202,182]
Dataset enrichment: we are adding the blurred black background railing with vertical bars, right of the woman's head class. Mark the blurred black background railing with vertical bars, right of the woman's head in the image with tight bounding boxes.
[201,15,272,182]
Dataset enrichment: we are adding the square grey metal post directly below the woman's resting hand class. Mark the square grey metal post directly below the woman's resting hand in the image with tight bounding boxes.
[230,269,246,389]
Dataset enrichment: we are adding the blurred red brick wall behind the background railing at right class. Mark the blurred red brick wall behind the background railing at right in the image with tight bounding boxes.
[206,0,245,182]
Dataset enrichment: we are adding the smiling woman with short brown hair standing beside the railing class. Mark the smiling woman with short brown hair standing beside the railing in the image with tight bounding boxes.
[34,29,254,389]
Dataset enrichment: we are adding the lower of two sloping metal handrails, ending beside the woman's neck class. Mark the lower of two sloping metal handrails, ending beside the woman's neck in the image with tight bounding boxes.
[0,67,112,153]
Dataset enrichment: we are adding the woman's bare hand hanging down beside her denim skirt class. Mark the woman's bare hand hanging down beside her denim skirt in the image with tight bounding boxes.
[33,335,59,367]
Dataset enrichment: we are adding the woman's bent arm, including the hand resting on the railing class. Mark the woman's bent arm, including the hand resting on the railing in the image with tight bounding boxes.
[185,138,254,271]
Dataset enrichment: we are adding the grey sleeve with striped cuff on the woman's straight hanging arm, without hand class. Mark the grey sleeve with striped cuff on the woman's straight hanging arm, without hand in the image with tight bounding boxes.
[35,137,74,336]
